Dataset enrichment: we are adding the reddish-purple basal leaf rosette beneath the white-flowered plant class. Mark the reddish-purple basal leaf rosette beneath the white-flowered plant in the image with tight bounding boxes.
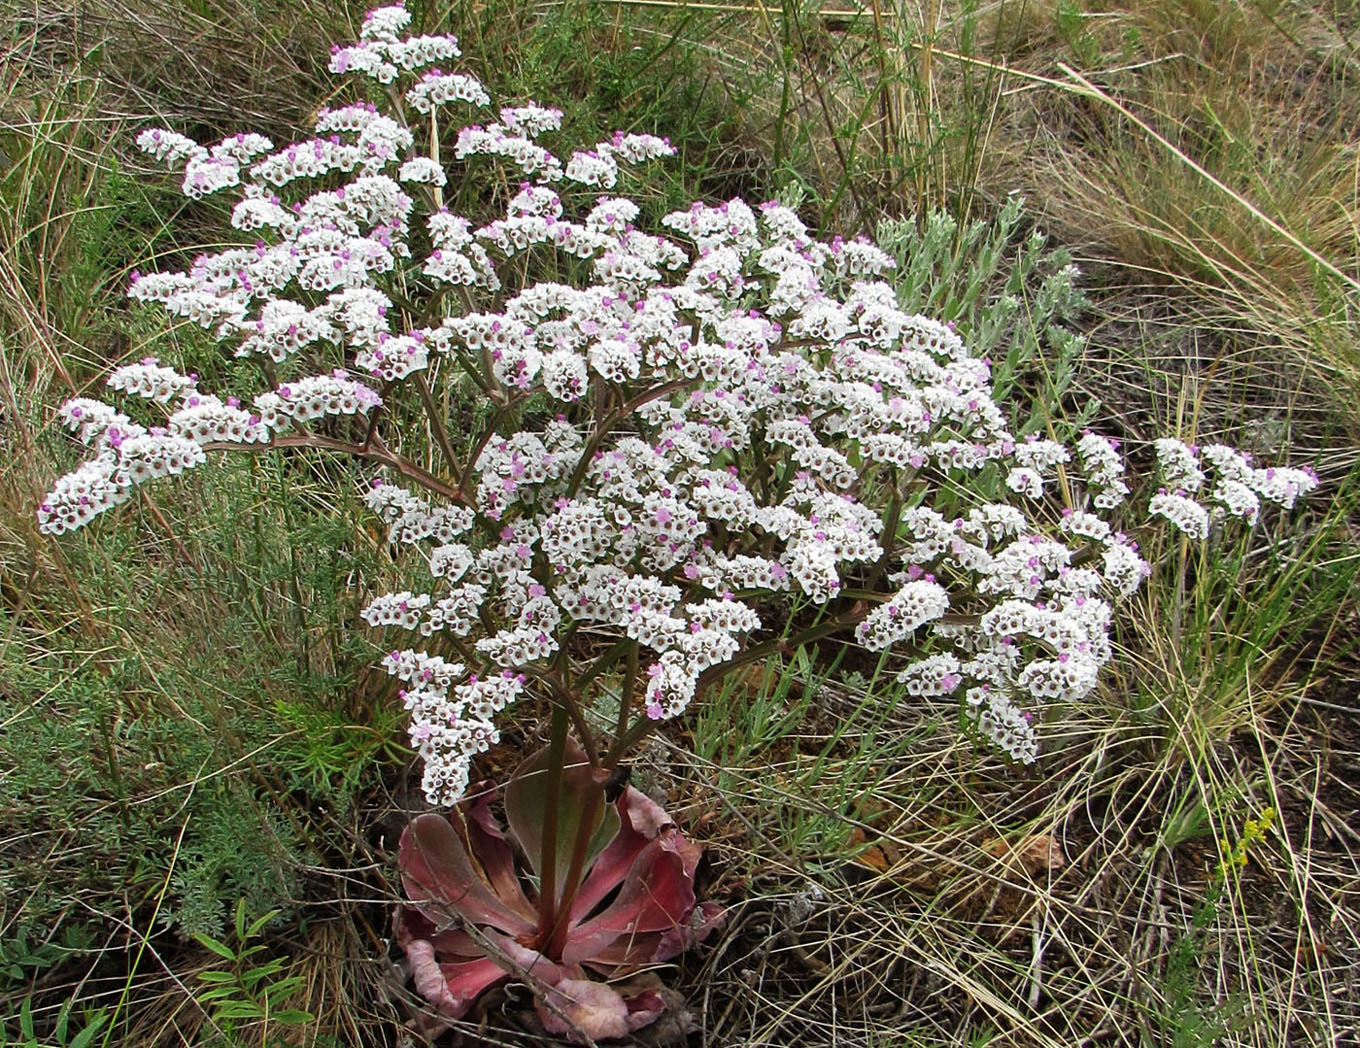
[396,744,722,1040]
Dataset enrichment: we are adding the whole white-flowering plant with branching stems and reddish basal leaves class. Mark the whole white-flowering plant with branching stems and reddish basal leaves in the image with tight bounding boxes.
[38,5,1316,1037]
